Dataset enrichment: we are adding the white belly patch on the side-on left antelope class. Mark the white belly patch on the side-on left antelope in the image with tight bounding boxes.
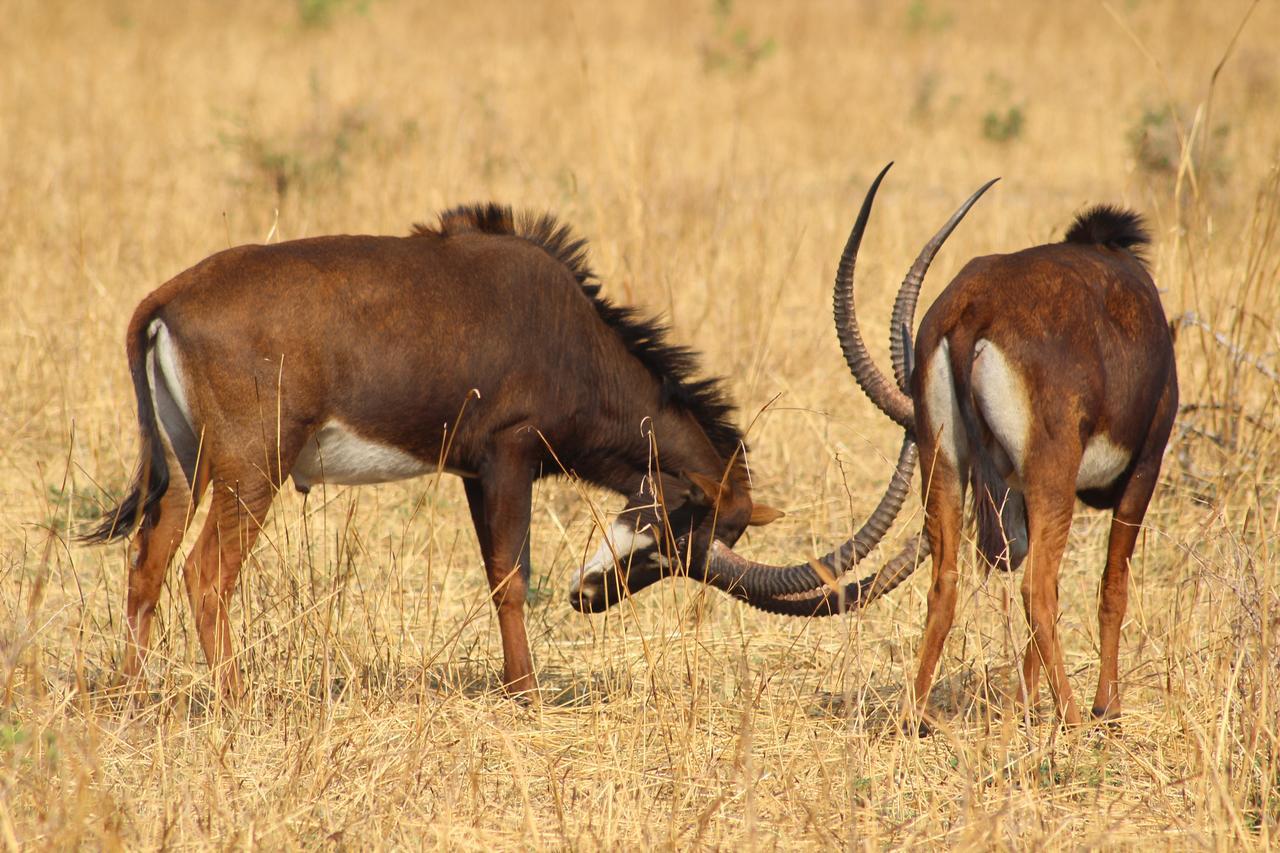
[291,420,435,489]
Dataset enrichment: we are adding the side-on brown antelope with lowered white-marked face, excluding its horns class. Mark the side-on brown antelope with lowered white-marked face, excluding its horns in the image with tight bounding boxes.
[86,205,778,695]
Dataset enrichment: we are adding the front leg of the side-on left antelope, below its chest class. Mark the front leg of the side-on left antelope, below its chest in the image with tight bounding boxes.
[465,440,538,697]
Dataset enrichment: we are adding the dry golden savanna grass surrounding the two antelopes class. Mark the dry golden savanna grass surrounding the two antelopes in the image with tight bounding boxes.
[0,0,1280,849]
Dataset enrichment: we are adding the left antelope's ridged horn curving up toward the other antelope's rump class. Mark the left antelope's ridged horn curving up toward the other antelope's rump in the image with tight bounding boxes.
[703,437,915,604]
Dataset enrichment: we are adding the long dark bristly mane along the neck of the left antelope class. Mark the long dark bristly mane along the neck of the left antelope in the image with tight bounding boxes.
[412,202,742,460]
